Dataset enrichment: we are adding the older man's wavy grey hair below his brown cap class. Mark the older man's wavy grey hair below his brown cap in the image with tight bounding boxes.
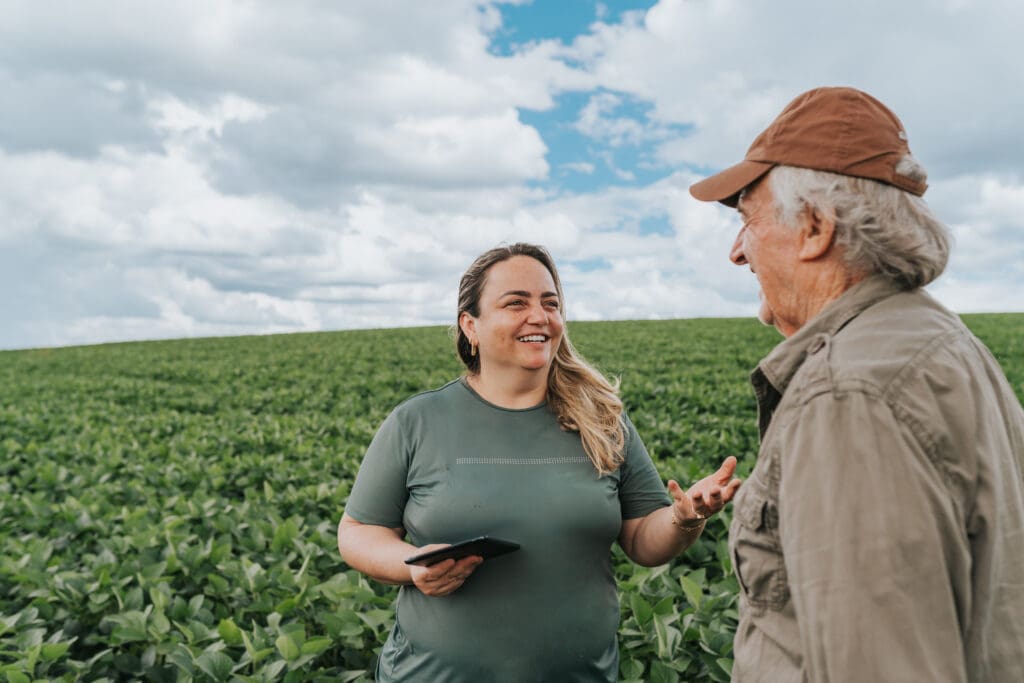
[768,156,950,289]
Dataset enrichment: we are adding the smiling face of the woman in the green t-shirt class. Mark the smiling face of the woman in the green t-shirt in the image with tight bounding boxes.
[459,256,564,373]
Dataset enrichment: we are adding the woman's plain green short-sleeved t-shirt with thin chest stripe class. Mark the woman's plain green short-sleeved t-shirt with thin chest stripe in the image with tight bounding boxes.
[346,380,671,683]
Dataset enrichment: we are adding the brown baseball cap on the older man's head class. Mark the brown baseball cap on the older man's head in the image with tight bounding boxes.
[690,87,928,207]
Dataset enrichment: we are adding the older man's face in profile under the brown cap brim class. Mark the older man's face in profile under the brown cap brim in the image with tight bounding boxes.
[729,174,805,337]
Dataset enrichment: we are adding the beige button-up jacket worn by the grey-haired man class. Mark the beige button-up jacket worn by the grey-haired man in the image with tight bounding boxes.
[729,278,1024,683]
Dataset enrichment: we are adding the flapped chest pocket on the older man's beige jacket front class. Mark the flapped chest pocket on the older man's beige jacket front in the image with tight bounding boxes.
[729,488,790,611]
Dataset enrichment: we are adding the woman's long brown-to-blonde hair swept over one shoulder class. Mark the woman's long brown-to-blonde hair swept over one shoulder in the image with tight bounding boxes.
[455,242,626,475]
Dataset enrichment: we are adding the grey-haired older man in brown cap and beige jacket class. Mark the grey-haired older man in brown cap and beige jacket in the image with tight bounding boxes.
[690,88,1024,682]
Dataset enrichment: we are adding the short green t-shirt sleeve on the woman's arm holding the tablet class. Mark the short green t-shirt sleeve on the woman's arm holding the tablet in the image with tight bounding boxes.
[345,408,410,528]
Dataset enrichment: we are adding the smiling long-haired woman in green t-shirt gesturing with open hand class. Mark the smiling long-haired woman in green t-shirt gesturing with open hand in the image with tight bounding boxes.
[338,244,739,683]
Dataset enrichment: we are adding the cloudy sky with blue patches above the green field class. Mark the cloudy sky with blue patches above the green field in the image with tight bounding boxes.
[0,0,1024,348]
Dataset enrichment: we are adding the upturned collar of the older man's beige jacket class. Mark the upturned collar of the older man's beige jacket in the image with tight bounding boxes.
[755,275,902,394]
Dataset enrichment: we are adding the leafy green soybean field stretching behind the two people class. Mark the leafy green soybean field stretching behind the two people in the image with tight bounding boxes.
[0,314,1024,683]
